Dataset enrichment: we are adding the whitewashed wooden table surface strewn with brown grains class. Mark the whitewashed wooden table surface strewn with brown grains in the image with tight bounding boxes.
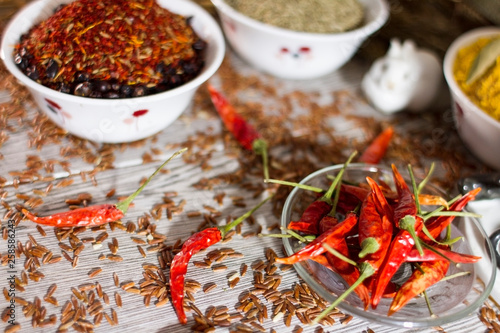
[0,7,499,333]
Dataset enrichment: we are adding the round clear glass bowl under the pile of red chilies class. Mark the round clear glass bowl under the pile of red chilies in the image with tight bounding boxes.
[281,164,496,328]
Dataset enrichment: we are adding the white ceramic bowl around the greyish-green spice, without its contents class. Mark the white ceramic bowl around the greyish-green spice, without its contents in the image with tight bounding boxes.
[212,0,389,79]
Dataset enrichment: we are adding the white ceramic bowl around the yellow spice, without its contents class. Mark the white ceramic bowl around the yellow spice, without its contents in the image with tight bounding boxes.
[443,27,500,170]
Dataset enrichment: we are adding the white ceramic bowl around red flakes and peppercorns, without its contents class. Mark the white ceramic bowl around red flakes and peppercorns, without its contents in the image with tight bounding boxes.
[0,0,225,143]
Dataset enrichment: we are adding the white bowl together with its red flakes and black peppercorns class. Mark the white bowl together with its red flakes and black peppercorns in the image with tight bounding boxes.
[0,0,225,143]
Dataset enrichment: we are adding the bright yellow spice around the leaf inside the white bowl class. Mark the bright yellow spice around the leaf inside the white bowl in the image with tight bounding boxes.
[453,38,500,121]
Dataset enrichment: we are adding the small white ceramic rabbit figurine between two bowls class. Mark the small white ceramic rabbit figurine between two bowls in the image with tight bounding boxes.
[361,39,442,113]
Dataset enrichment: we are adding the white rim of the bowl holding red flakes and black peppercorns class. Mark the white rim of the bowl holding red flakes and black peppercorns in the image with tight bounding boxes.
[0,0,225,105]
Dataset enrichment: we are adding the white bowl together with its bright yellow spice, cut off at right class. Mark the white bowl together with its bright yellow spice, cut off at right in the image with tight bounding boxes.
[443,27,500,170]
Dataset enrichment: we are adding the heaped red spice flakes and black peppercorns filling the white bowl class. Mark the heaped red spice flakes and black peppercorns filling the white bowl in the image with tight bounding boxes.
[13,0,207,98]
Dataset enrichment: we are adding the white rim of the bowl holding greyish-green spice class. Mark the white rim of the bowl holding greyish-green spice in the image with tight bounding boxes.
[211,0,389,41]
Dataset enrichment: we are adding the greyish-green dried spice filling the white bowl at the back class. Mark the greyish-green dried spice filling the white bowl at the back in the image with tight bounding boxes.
[225,0,364,33]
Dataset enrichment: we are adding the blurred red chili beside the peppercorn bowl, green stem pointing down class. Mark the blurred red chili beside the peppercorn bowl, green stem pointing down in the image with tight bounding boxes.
[208,84,269,179]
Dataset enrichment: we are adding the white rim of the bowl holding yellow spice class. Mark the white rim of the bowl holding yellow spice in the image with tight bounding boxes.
[443,26,500,130]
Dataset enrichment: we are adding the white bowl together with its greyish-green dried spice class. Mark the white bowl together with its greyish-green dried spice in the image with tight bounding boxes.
[212,0,389,79]
